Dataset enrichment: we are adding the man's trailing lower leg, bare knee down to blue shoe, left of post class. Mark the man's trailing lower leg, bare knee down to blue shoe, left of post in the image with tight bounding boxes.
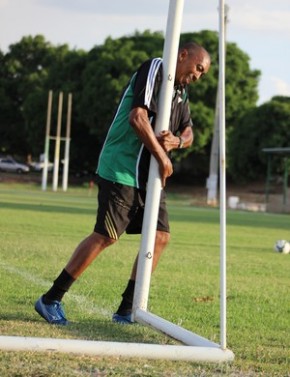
[35,232,116,325]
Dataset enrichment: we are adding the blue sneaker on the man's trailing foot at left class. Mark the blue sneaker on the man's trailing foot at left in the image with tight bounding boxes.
[34,296,69,326]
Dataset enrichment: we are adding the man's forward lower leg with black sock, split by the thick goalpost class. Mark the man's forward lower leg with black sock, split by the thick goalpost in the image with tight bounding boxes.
[113,230,170,324]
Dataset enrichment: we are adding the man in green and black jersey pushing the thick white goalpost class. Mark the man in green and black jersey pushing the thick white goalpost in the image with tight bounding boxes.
[35,43,210,325]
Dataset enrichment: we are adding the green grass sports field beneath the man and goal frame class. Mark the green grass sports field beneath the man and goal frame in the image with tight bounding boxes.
[0,183,290,377]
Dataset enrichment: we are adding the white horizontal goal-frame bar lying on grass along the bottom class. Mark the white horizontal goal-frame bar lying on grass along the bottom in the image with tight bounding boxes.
[0,336,234,363]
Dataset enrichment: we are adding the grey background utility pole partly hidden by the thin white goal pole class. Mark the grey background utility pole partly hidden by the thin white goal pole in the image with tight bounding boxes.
[206,4,229,207]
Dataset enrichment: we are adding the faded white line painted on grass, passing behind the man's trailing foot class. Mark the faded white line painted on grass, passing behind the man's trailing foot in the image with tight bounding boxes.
[0,262,112,317]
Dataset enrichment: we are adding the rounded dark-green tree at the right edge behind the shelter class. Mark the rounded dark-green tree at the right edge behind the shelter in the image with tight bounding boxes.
[228,96,290,182]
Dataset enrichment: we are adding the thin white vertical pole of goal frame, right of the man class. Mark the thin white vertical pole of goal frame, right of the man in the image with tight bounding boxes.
[218,0,227,349]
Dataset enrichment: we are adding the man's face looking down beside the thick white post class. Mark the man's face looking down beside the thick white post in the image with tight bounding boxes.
[175,50,210,86]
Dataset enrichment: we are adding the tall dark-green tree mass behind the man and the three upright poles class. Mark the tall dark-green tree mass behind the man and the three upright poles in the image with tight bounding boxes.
[0,30,270,181]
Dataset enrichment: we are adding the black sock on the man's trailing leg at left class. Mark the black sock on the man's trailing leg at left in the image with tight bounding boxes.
[43,270,75,304]
